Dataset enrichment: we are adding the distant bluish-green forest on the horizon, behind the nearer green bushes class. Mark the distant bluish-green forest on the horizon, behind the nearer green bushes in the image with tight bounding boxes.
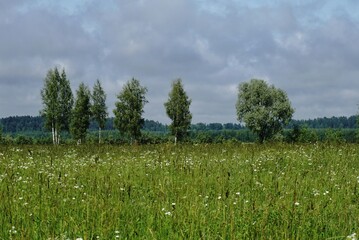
[0,116,357,134]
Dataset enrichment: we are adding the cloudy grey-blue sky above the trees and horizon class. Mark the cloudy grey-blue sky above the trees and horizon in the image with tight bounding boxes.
[0,0,359,123]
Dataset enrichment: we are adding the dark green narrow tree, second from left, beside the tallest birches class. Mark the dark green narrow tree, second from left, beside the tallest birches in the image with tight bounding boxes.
[70,83,91,143]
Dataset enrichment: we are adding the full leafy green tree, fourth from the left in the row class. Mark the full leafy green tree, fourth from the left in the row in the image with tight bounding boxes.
[113,78,147,142]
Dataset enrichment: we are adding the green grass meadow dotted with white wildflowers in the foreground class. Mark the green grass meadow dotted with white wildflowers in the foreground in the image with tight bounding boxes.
[0,144,359,239]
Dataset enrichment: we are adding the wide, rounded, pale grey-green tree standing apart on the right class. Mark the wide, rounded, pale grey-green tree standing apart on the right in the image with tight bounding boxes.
[236,79,294,143]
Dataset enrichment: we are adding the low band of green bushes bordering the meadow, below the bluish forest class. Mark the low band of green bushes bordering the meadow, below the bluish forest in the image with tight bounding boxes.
[0,127,359,145]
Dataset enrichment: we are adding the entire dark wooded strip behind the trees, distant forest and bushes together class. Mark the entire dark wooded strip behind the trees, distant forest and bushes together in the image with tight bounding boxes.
[0,116,359,144]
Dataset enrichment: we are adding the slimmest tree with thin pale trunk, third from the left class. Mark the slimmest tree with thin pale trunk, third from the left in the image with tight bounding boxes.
[91,79,108,143]
